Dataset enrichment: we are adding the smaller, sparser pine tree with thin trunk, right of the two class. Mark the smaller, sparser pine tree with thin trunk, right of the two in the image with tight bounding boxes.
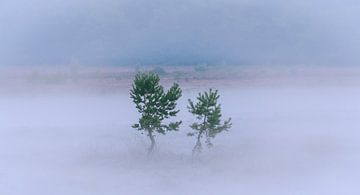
[188,89,232,155]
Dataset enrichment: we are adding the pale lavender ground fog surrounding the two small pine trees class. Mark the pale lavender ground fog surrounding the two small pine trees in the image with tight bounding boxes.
[0,81,360,195]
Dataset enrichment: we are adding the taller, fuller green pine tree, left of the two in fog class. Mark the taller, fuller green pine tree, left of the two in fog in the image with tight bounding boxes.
[130,73,182,154]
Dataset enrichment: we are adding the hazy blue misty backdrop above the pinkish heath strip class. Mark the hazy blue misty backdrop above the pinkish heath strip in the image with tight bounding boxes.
[0,0,360,65]
